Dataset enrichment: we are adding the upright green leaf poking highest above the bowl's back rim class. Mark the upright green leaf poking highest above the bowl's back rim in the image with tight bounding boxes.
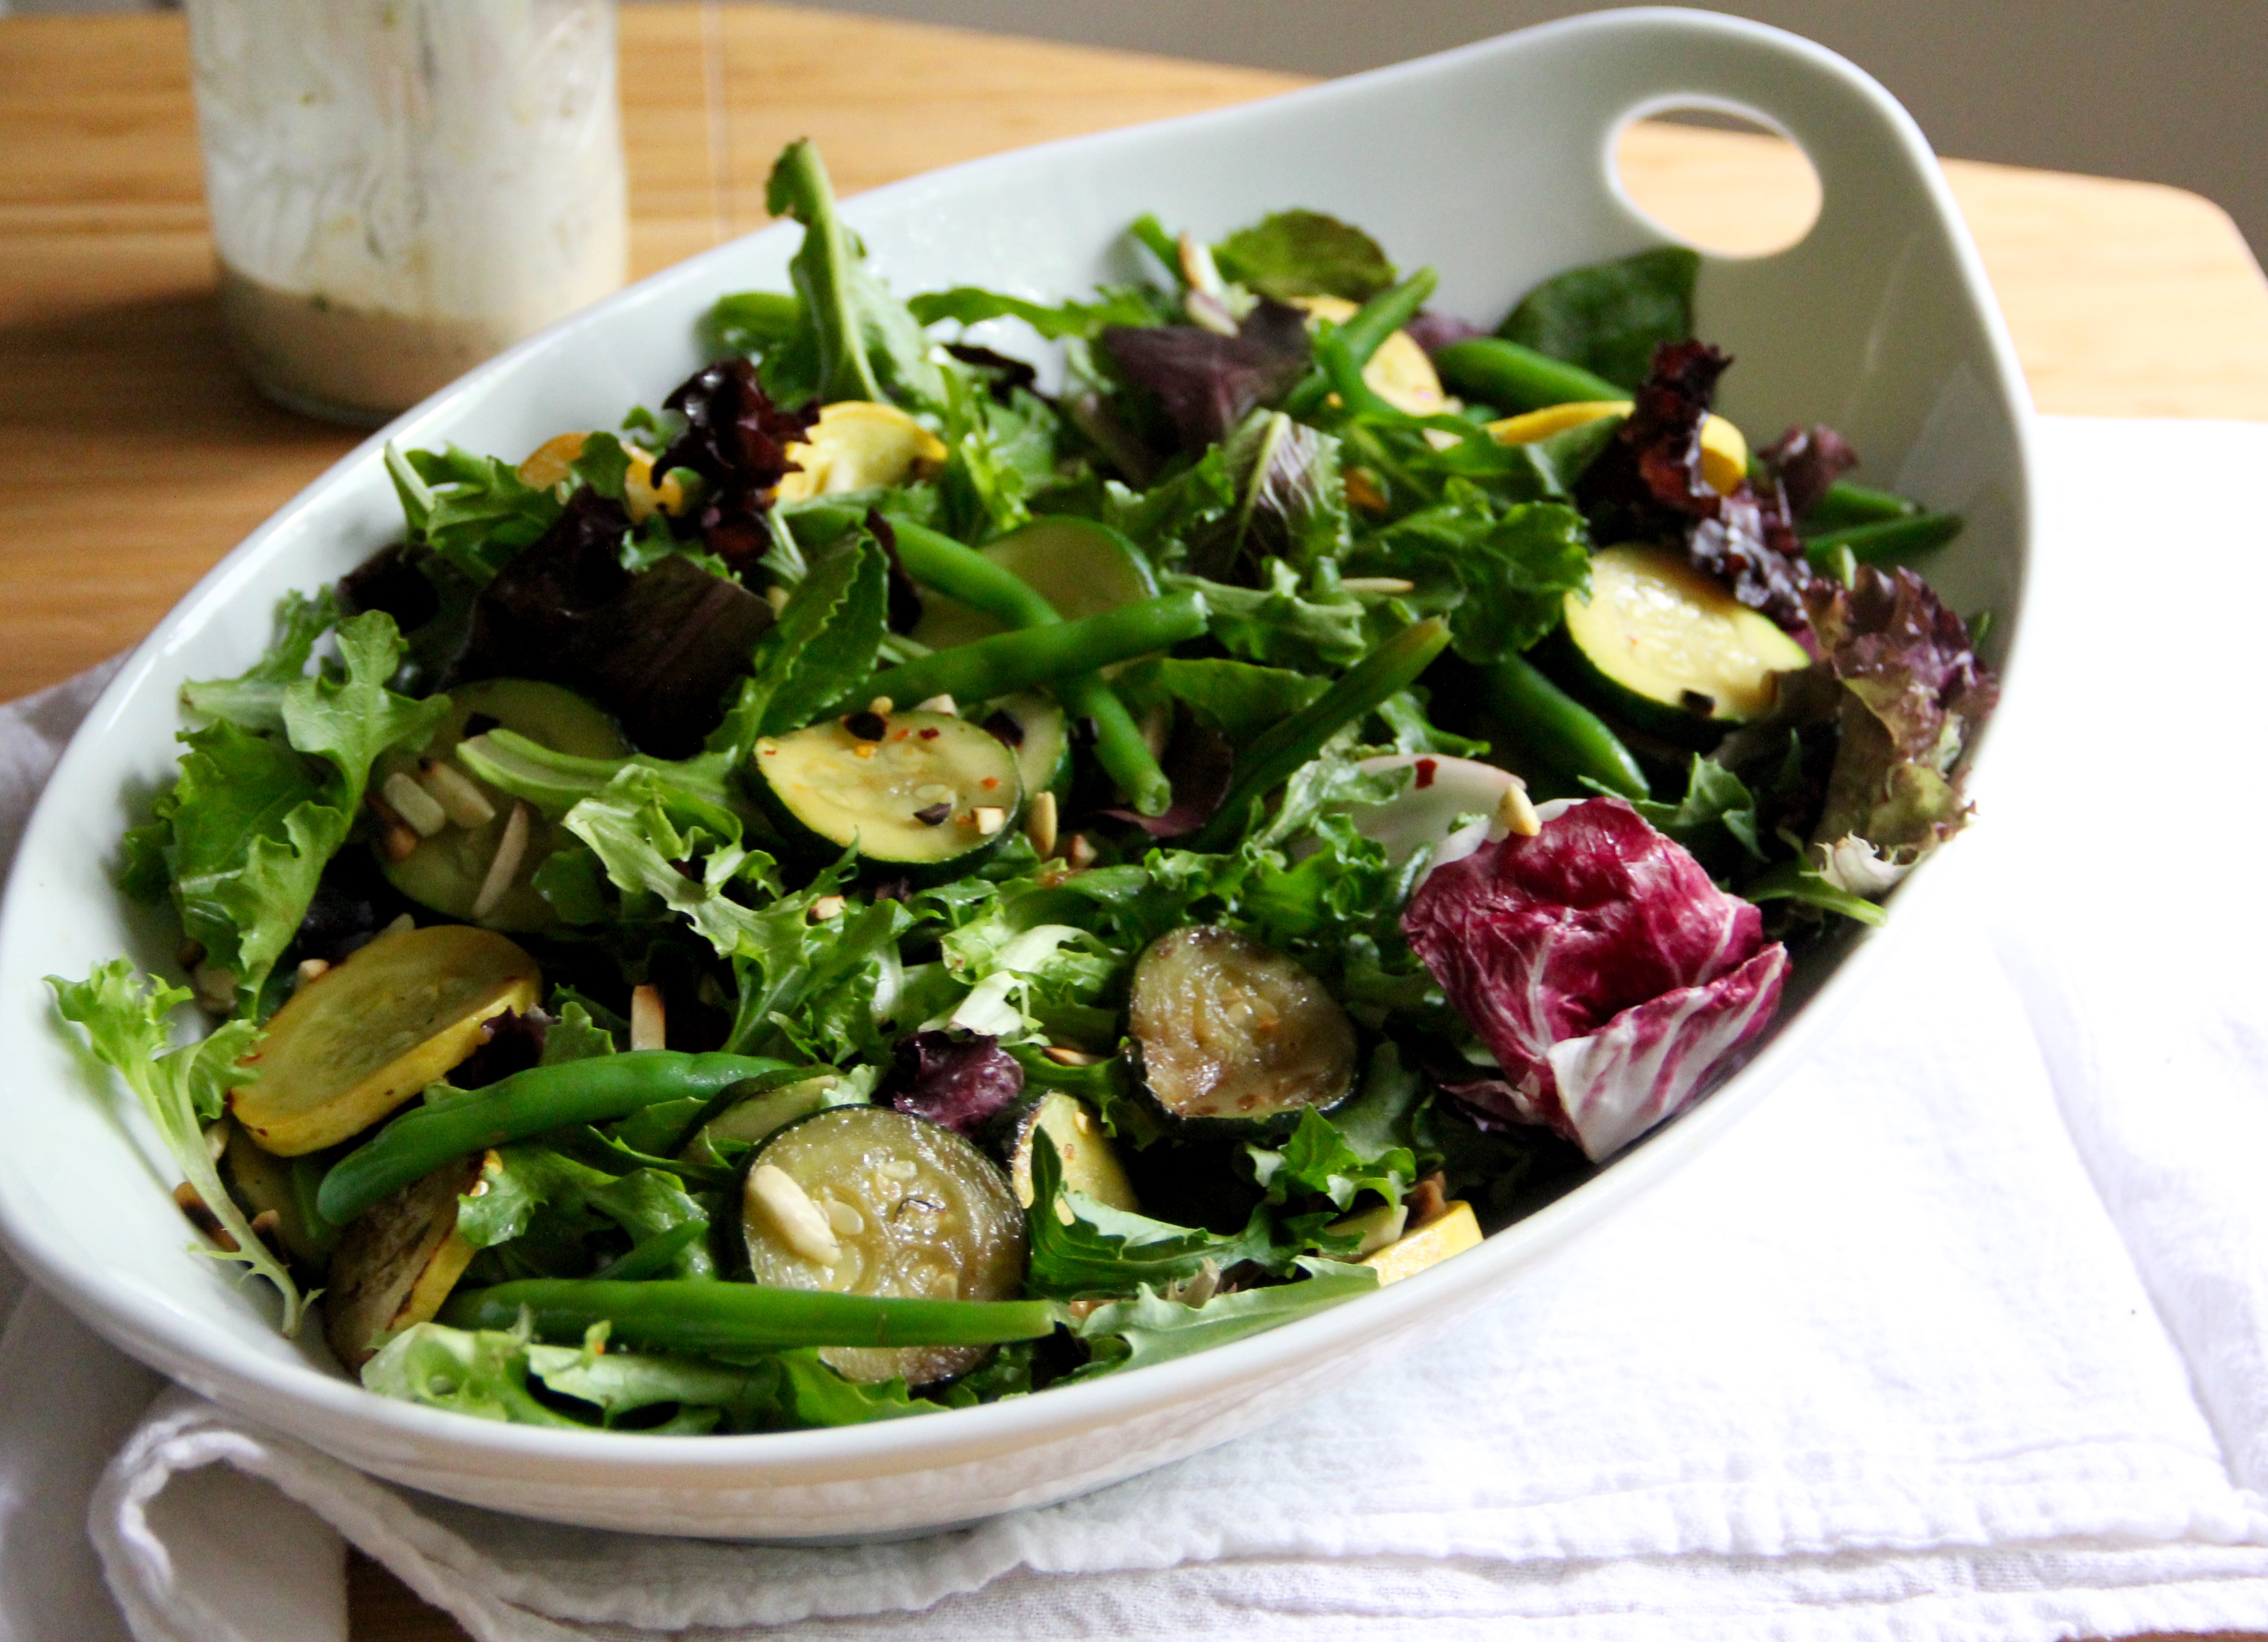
[765,138,943,408]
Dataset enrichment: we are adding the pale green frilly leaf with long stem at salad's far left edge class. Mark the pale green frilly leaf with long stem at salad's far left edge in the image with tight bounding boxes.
[48,957,313,1334]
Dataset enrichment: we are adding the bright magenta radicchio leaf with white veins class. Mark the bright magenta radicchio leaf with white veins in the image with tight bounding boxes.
[1401,798,1787,1161]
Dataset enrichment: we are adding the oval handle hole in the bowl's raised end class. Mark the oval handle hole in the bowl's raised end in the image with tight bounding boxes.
[1615,102,1821,256]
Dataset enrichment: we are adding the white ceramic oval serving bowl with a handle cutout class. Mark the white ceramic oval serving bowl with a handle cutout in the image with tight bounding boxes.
[0,9,2030,1538]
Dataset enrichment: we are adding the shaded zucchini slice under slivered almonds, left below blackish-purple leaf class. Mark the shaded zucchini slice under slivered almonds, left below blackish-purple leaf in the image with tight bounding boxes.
[370,678,633,930]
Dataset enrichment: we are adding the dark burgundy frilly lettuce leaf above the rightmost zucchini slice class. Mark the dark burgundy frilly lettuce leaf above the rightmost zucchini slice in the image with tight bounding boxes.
[1576,342,1812,630]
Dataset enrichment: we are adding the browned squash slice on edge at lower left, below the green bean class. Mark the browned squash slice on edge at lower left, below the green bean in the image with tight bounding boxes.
[322,1152,494,1370]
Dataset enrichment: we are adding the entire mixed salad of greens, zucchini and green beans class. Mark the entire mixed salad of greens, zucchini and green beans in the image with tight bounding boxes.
[54,143,1993,1431]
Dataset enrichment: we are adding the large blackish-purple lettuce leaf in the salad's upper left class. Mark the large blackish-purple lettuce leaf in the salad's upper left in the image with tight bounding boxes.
[442,490,771,757]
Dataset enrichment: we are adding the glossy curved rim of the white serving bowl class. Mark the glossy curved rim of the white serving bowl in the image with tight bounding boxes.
[0,7,2037,1483]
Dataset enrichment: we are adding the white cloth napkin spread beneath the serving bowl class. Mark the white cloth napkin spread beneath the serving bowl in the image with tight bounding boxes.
[13,422,2268,1642]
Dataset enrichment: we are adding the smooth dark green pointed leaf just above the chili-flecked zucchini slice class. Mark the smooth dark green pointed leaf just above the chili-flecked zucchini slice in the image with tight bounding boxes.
[710,531,889,744]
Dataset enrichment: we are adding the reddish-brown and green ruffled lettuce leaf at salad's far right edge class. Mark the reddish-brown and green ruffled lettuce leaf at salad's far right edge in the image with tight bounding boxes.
[1805,565,2000,862]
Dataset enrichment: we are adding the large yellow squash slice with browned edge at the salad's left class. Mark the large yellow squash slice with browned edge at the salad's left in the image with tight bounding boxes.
[229,923,544,1157]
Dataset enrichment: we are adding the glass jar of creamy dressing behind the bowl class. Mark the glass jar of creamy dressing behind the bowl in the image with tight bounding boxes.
[188,0,628,424]
